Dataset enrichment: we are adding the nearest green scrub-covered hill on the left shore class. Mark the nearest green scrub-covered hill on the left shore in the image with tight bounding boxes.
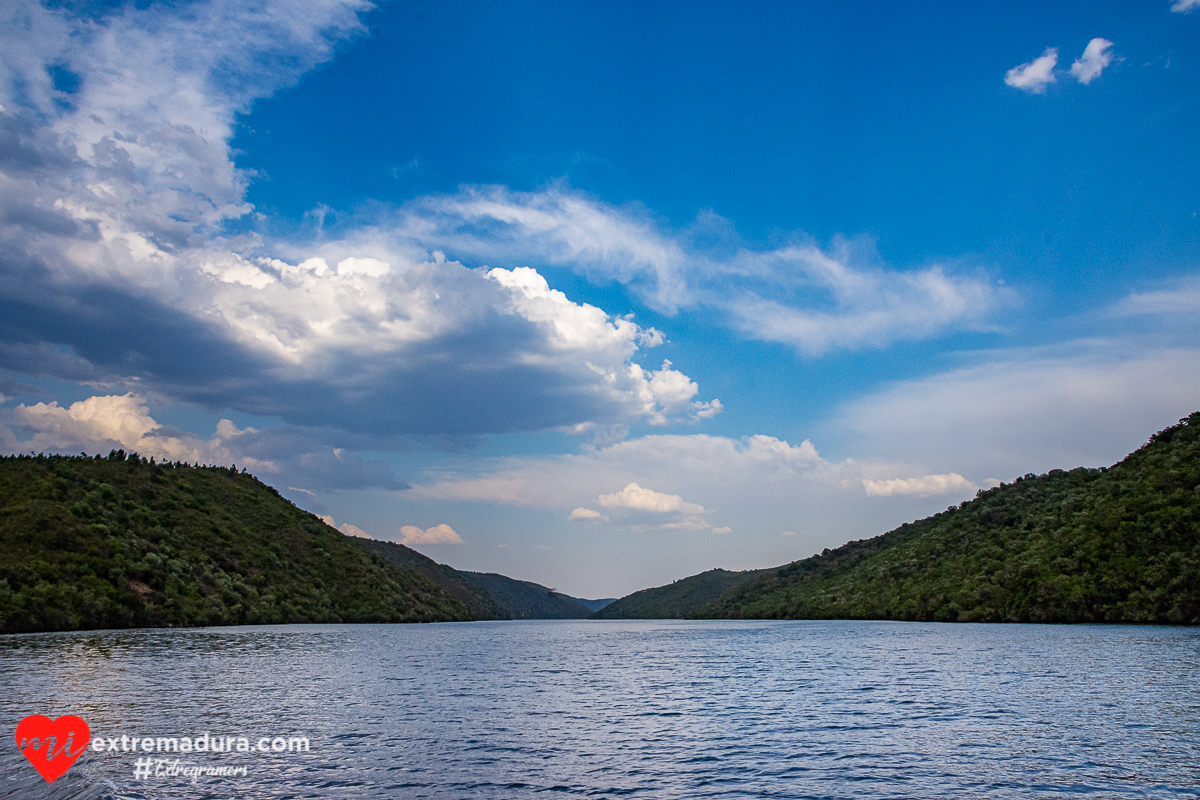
[0,451,470,633]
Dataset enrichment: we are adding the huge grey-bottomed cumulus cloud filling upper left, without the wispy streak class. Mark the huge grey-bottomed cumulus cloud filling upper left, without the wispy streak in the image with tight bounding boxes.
[0,0,720,447]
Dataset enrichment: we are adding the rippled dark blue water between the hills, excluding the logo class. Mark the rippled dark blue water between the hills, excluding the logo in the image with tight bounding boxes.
[0,621,1200,799]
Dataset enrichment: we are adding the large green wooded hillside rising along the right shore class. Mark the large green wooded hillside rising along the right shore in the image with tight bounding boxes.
[690,413,1200,625]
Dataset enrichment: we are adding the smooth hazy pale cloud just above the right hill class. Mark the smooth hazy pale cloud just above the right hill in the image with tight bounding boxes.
[823,341,1200,483]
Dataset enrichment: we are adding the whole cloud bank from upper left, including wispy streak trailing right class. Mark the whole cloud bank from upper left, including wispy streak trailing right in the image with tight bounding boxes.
[0,0,1000,462]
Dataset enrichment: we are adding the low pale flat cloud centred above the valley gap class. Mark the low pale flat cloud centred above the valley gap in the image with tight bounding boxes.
[406,434,936,544]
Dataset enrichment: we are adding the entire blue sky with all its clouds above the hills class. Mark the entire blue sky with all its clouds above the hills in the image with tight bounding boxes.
[0,0,1200,597]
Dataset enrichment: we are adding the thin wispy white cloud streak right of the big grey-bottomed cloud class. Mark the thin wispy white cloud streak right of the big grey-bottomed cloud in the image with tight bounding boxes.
[392,186,1004,355]
